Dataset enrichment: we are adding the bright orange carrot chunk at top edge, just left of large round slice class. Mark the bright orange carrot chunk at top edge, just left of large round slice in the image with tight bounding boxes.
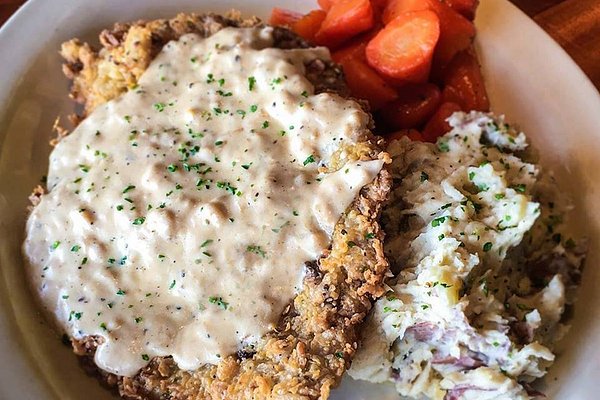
[315,0,374,47]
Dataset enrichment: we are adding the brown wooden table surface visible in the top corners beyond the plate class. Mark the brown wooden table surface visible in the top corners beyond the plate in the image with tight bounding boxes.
[0,0,600,89]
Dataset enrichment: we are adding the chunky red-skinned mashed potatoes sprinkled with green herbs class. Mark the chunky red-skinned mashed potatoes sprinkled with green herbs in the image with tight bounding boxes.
[350,112,585,400]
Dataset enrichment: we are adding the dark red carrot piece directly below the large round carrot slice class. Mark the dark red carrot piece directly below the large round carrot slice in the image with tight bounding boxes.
[380,83,442,130]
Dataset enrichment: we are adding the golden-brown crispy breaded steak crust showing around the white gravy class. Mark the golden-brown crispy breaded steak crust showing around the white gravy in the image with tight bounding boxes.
[61,10,390,399]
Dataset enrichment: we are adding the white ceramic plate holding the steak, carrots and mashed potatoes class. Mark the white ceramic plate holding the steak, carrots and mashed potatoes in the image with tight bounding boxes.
[0,0,600,400]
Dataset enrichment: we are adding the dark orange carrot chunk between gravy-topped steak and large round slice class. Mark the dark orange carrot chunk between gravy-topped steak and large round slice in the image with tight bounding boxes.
[340,57,398,110]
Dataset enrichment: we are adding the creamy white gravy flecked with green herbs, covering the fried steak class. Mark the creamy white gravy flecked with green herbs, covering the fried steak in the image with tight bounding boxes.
[24,28,382,376]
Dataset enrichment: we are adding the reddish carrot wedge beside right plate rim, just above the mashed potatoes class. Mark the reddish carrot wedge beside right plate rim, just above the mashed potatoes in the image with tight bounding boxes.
[442,51,490,111]
